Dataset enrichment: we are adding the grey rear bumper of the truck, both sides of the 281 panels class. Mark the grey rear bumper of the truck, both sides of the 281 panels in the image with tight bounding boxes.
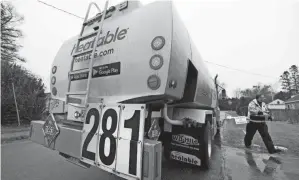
[30,121,162,180]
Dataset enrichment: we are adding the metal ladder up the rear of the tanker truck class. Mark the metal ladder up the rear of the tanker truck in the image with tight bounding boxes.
[66,0,109,108]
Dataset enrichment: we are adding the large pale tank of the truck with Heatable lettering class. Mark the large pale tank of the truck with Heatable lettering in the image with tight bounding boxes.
[51,1,216,108]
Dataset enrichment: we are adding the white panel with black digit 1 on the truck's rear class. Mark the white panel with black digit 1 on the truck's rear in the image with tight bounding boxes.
[116,104,145,179]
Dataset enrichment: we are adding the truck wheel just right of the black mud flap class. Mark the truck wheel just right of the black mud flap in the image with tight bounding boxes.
[200,121,213,169]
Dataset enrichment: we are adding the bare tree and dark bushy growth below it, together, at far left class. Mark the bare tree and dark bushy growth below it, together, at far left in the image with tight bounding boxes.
[1,1,46,125]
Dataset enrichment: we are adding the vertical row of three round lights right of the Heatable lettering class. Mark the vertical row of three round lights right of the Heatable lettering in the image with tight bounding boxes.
[147,36,165,90]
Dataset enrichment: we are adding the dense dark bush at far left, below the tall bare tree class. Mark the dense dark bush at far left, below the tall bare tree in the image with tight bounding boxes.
[1,61,46,124]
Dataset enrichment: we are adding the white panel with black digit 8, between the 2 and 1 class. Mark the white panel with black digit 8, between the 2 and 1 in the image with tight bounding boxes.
[97,105,120,169]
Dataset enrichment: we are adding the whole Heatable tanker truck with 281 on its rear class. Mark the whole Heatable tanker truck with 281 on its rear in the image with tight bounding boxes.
[30,1,225,180]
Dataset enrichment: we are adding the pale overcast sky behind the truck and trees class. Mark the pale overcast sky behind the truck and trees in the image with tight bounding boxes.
[11,0,299,96]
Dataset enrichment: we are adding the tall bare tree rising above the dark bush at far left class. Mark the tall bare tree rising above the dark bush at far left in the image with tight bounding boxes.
[1,1,25,62]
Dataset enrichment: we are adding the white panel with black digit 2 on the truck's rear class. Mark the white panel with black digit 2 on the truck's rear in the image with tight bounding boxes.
[81,104,101,165]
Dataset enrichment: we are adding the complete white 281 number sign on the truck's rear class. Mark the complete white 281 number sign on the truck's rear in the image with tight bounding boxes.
[81,104,145,179]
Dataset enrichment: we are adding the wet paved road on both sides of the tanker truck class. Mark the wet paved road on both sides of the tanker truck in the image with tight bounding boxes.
[1,119,299,180]
